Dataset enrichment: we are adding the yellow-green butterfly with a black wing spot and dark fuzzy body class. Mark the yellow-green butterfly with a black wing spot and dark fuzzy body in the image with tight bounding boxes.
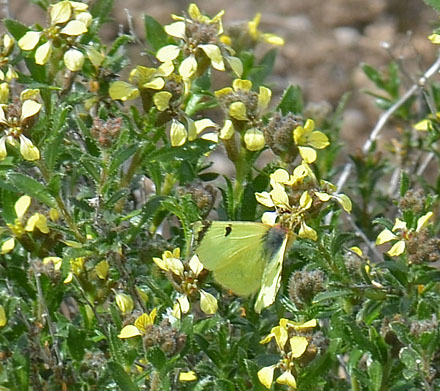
[196,221,291,313]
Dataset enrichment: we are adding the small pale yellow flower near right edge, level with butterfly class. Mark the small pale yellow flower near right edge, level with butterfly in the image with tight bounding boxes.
[376,212,433,257]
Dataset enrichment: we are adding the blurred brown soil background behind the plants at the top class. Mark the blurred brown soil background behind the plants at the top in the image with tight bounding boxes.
[2,0,438,147]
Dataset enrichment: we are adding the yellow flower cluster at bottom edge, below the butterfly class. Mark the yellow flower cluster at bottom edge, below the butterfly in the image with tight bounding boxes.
[258,318,317,389]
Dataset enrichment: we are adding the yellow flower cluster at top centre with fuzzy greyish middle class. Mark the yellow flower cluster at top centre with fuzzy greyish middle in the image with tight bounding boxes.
[156,3,243,80]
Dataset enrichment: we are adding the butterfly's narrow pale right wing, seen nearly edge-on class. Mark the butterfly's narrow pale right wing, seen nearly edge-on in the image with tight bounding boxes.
[254,231,289,314]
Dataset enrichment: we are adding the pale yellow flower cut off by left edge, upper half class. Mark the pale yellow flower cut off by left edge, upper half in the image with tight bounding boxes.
[0,90,41,161]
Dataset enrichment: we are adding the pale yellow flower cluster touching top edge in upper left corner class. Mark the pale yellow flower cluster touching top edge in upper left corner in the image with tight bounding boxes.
[18,0,92,71]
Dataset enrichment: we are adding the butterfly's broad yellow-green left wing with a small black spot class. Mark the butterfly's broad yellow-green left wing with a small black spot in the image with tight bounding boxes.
[196,221,271,296]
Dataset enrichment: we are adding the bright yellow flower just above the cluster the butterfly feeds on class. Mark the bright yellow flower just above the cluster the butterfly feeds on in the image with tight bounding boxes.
[293,119,330,164]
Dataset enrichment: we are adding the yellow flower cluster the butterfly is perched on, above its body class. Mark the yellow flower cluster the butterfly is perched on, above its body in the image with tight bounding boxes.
[255,161,352,240]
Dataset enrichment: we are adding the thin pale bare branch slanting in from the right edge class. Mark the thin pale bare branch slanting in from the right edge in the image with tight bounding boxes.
[336,55,440,192]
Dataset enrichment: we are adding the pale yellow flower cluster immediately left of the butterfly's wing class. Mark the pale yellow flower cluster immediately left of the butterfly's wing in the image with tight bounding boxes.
[153,248,217,319]
